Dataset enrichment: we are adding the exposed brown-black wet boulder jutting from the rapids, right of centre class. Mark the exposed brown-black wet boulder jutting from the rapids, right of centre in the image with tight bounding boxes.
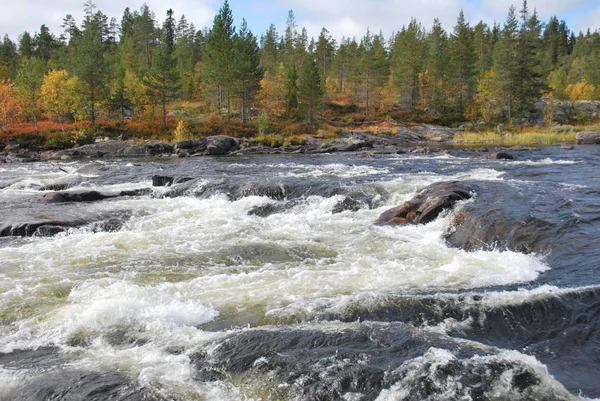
[376,181,472,225]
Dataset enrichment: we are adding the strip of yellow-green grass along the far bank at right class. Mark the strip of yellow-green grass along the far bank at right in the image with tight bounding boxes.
[454,130,576,146]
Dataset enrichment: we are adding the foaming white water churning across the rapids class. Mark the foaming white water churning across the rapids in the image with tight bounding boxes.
[0,159,580,400]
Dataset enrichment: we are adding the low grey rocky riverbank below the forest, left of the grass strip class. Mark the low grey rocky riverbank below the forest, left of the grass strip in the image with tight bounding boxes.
[0,124,454,163]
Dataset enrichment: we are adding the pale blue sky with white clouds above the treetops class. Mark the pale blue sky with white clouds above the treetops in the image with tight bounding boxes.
[0,0,600,41]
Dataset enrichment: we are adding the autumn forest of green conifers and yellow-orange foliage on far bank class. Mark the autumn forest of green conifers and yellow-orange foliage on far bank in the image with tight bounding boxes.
[0,0,600,145]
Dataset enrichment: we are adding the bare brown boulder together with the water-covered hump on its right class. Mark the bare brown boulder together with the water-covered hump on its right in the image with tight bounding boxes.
[376,181,564,254]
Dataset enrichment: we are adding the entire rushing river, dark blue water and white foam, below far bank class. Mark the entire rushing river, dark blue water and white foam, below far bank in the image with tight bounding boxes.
[0,147,600,401]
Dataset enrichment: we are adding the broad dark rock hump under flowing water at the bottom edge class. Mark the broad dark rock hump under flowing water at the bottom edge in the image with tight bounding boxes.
[192,322,570,400]
